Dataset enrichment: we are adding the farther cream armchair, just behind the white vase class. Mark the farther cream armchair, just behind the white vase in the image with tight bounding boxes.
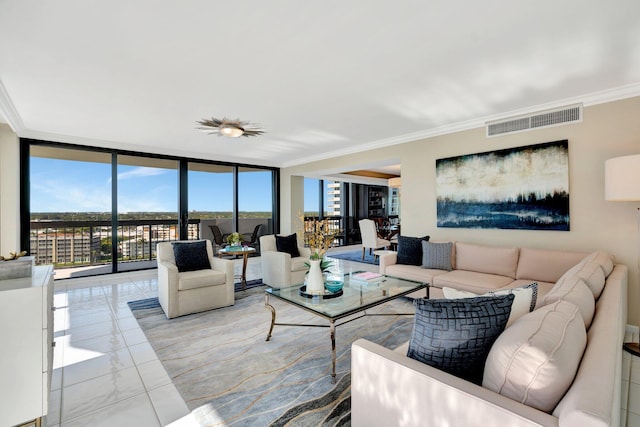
[260,234,311,288]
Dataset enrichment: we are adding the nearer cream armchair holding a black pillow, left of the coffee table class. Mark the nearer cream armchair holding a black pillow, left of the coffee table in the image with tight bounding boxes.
[157,240,235,319]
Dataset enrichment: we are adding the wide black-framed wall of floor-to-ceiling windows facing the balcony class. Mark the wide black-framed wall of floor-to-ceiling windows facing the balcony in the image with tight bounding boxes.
[21,139,279,279]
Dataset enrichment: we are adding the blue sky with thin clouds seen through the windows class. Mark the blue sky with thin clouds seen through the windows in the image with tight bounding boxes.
[30,157,326,213]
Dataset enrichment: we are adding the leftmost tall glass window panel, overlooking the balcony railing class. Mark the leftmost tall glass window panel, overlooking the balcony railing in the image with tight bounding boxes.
[29,145,113,277]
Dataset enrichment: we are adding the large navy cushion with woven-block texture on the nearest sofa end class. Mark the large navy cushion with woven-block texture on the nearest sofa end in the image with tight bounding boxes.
[407,295,514,384]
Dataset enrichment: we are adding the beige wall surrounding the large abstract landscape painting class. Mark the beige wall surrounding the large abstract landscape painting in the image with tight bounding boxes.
[281,97,640,325]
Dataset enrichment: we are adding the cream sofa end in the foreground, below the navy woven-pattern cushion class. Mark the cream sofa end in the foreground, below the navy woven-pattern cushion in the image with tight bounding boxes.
[351,339,558,427]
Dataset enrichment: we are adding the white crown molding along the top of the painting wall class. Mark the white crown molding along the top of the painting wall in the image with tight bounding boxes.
[281,83,640,167]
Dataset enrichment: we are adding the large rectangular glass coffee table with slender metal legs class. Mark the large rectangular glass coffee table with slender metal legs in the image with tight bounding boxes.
[264,271,429,382]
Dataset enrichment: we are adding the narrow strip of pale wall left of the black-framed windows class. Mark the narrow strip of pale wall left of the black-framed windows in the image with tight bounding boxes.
[0,123,23,256]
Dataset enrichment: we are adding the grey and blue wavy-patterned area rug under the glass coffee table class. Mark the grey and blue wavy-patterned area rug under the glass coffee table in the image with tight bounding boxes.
[130,288,414,426]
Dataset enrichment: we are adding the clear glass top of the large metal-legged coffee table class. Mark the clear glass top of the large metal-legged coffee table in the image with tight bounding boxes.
[265,271,428,319]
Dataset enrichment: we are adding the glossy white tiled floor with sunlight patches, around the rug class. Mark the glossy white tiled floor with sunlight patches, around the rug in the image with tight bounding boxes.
[46,251,640,427]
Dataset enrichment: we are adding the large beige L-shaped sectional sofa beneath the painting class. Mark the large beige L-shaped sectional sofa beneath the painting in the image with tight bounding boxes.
[351,242,627,427]
